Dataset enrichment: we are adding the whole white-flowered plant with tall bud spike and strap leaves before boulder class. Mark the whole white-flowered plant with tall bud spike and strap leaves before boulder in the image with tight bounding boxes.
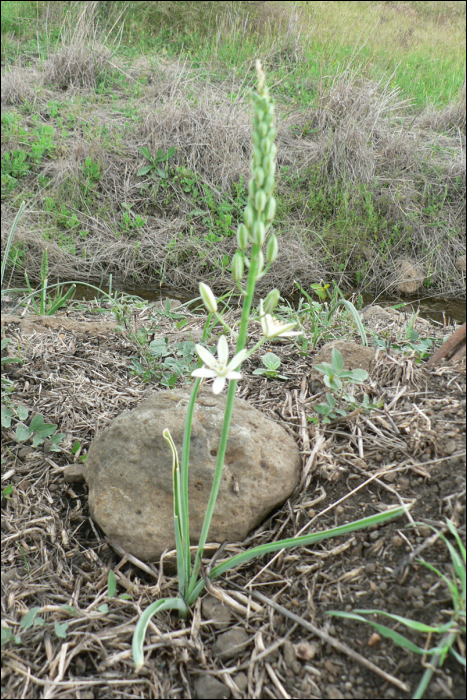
[133,61,405,668]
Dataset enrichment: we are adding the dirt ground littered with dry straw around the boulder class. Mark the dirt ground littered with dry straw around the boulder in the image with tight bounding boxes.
[2,304,465,698]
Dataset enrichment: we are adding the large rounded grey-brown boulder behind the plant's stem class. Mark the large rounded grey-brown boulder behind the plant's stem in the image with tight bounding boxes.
[84,389,301,561]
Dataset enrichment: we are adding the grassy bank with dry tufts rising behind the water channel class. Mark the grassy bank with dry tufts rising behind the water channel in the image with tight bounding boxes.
[2,2,465,295]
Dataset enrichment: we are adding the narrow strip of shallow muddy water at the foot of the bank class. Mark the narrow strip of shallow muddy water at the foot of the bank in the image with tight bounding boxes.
[74,285,466,325]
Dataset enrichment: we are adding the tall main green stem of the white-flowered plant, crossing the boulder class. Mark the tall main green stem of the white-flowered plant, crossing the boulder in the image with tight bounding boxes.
[187,246,261,605]
